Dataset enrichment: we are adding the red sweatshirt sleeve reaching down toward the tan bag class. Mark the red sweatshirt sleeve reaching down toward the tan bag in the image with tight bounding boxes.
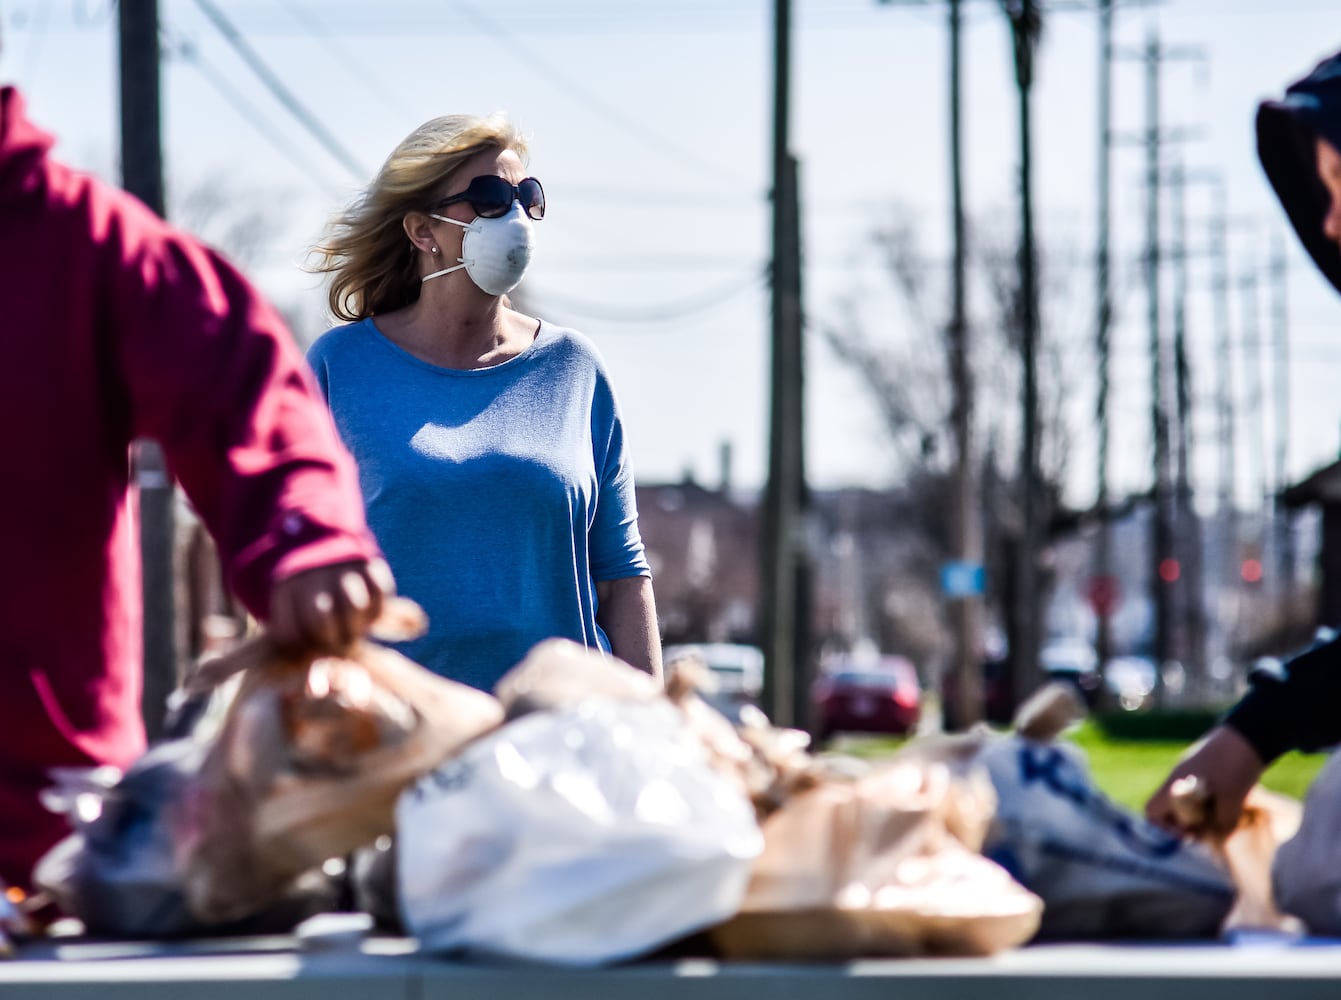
[95,183,377,618]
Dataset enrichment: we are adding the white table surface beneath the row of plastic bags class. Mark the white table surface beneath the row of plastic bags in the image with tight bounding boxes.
[0,938,1341,1000]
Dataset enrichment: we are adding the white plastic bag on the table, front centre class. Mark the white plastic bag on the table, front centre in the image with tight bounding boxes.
[396,697,763,965]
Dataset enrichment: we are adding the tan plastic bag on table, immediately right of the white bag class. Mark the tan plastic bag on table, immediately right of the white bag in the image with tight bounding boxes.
[711,761,1043,960]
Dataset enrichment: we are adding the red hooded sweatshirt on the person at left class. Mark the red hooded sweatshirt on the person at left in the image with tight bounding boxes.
[0,87,377,886]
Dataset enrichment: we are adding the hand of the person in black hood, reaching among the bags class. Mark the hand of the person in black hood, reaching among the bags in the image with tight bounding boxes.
[1145,725,1266,836]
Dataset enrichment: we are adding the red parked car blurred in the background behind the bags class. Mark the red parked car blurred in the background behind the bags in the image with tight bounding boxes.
[811,655,921,743]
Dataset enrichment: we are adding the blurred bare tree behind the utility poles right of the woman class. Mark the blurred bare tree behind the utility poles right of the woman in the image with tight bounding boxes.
[815,208,1088,718]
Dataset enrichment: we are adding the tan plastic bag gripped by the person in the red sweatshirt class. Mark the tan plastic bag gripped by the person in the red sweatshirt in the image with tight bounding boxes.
[172,600,503,922]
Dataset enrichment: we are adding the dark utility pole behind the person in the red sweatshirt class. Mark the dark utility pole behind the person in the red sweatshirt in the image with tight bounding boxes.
[118,0,177,740]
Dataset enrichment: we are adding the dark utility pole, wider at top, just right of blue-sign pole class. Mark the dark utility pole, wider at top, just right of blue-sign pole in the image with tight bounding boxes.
[1002,0,1043,701]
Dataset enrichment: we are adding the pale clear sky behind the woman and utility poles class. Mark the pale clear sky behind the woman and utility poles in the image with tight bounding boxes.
[0,0,1341,503]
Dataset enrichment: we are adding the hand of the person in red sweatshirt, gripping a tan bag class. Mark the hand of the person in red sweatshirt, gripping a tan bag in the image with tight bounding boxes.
[267,559,396,653]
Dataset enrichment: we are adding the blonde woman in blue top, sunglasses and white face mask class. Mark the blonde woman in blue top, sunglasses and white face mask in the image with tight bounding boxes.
[308,115,661,689]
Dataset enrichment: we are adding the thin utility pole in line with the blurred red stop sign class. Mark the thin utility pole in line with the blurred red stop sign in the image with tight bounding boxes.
[1092,0,1117,674]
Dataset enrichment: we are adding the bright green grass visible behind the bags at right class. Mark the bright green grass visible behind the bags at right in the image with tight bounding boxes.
[833,721,1326,812]
